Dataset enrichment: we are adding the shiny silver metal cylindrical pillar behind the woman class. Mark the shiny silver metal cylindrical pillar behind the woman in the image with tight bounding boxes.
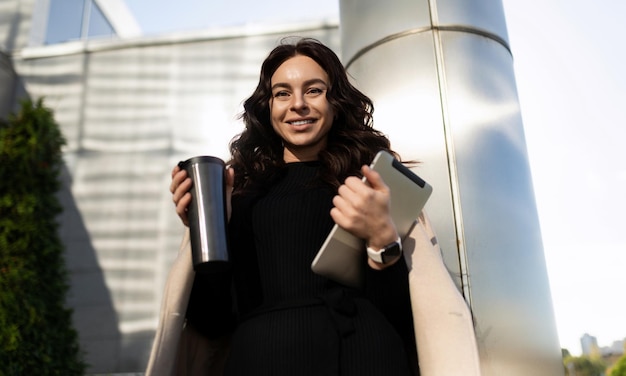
[340,0,563,376]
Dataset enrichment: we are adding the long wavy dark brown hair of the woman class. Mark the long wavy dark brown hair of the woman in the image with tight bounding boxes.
[228,38,396,193]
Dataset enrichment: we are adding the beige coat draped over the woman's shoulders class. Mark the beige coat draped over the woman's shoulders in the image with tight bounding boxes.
[146,214,480,376]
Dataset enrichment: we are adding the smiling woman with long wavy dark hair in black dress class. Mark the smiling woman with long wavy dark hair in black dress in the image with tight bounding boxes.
[148,39,473,376]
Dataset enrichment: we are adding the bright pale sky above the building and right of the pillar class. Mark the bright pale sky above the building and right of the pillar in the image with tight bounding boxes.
[126,0,626,355]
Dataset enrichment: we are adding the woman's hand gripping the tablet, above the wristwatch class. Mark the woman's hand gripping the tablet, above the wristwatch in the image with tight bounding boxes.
[330,166,398,269]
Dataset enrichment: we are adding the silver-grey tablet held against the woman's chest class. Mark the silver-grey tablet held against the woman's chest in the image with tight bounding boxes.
[311,151,433,287]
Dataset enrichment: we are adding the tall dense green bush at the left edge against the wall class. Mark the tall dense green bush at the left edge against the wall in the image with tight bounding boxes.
[0,100,86,376]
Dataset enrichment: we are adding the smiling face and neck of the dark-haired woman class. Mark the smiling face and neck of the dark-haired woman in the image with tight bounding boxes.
[270,55,334,162]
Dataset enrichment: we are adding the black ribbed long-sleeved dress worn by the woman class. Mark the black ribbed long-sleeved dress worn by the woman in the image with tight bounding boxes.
[187,162,416,376]
